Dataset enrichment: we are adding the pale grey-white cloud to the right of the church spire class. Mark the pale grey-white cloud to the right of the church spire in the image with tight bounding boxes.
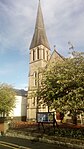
[39,0,84,54]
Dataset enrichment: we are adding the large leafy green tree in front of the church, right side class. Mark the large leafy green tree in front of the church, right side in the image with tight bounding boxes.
[37,53,84,124]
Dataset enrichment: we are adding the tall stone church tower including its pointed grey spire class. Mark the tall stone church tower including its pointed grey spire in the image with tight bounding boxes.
[27,0,50,120]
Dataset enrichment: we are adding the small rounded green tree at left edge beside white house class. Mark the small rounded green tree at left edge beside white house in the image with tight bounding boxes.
[0,84,15,117]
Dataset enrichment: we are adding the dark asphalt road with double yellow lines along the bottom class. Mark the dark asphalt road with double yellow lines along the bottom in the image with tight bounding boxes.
[0,137,71,149]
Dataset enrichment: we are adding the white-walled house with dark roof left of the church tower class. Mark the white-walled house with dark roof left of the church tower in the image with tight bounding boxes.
[9,89,27,121]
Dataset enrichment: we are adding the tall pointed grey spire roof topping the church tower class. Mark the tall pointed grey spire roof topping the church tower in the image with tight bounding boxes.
[30,1,50,49]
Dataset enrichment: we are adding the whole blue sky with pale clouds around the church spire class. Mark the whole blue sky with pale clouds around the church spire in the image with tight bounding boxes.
[0,0,84,89]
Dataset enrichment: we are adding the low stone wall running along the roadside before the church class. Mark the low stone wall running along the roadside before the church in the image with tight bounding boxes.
[6,131,84,149]
